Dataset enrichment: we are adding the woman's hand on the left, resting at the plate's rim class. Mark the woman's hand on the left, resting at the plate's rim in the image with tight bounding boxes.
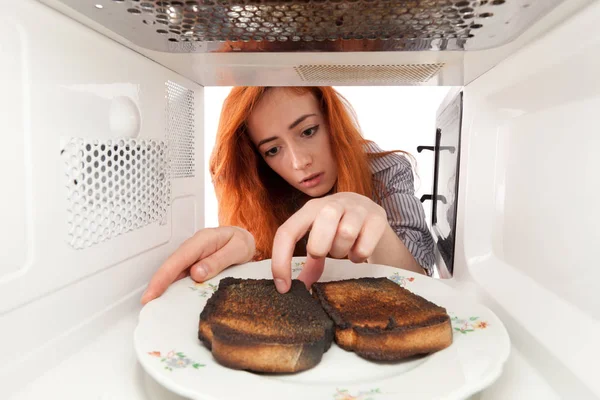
[142,226,256,304]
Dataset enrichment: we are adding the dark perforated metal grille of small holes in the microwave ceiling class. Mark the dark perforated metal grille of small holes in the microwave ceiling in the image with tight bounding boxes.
[126,0,496,42]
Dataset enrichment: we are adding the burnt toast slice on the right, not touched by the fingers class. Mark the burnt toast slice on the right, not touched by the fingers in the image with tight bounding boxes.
[312,278,452,361]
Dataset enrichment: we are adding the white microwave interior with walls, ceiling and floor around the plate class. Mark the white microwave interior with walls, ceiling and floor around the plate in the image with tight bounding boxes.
[0,0,600,400]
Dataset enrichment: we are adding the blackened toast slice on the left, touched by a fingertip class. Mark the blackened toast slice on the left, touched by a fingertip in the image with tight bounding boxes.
[198,278,333,373]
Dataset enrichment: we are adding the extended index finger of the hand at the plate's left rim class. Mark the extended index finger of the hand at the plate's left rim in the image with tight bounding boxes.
[142,229,218,304]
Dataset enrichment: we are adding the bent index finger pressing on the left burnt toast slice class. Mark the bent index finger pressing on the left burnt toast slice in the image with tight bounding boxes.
[271,204,316,293]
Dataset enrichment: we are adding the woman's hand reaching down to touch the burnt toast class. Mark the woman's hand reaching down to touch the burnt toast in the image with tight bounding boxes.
[271,193,389,293]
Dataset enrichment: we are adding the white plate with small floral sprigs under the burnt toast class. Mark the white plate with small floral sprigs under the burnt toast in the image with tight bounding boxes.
[134,258,510,400]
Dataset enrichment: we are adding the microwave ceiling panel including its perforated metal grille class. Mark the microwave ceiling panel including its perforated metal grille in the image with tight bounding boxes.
[55,0,563,53]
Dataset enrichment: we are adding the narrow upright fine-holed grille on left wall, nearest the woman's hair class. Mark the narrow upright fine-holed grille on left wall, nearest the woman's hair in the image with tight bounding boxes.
[166,81,195,178]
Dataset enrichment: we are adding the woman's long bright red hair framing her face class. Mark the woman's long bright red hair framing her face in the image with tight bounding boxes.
[210,86,388,260]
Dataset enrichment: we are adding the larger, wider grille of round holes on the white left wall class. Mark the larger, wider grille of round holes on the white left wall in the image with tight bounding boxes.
[62,139,171,249]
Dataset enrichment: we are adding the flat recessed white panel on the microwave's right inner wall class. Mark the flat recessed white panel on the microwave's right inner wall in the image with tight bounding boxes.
[497,102,600,320]
